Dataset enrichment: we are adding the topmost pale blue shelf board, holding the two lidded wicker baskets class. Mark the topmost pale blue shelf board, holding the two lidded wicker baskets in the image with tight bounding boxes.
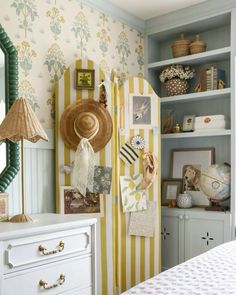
[148,47,231,70]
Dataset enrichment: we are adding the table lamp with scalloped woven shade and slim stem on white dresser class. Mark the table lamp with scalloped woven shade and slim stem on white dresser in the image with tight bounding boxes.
[0,98,48,222]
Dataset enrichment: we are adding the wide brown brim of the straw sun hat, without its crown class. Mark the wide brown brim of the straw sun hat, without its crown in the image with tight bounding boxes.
[60,99,113,152]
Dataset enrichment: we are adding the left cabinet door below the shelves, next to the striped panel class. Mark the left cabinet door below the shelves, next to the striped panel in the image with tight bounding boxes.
[161,208,184,270]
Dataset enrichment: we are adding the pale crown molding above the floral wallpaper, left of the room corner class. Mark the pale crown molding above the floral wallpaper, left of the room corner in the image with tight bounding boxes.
[83,0,145,32]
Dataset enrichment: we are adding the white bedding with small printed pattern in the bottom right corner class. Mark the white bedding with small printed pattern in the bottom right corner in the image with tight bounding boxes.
[122,241,236,295]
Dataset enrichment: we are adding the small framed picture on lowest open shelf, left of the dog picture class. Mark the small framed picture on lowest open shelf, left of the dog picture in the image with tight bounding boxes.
[161,178,183,206]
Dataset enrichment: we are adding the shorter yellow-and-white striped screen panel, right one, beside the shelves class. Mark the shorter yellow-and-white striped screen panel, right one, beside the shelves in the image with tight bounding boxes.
[117,78,161,292]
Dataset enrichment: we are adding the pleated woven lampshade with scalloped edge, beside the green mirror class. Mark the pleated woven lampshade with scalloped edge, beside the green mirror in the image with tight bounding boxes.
[0,98,48,142]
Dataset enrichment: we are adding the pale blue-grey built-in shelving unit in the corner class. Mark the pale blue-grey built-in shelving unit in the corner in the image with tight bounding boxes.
[146,2,236,247]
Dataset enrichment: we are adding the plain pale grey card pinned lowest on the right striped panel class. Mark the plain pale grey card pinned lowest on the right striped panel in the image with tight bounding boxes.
[129,201,156,237]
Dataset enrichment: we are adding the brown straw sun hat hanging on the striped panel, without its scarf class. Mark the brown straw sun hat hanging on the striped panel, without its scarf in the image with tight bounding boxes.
[60,99,113,152]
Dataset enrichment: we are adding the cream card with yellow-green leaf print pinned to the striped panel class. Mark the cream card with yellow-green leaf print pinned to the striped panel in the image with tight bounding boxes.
[120,174,147,212]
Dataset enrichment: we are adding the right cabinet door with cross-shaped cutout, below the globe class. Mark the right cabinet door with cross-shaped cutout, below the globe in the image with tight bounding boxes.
[184,210,230,260]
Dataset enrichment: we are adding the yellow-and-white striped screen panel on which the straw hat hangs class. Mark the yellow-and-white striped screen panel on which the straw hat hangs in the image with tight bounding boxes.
[55,59,117,295]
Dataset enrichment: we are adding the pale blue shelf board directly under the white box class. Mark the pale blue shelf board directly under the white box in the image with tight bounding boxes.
[161,129,231,139]
